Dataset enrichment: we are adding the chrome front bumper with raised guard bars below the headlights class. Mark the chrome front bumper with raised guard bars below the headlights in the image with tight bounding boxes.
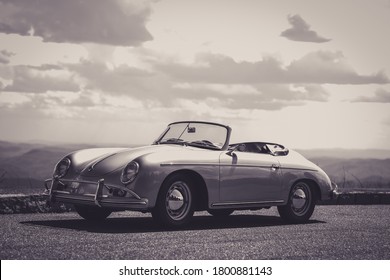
[45,177,148,210]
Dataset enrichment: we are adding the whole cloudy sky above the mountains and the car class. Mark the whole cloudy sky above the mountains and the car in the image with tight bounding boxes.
[0,0,390,149]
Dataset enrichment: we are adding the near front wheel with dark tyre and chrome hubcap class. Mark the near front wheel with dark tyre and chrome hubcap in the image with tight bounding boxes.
[152,175,194,227]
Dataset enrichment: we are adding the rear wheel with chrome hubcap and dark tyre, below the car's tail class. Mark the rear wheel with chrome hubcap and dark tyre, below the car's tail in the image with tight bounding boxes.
[278,182,316,223]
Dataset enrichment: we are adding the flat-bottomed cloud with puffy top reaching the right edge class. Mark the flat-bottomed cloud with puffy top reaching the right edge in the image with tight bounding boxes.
[155,51,390,84]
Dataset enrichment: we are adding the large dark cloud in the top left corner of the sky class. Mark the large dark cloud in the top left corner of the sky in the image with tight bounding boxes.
[0,0,152,46]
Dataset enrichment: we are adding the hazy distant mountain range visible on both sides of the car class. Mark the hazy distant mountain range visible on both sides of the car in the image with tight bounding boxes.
[0,141,390,194]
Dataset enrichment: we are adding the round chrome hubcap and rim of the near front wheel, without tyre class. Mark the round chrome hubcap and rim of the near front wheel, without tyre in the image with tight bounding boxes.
[165,182,191,220]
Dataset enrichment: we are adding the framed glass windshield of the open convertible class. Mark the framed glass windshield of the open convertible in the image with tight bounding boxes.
[155,122,229,150]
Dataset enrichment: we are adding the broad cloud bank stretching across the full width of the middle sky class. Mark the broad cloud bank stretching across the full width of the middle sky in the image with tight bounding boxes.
[0,48,389,117]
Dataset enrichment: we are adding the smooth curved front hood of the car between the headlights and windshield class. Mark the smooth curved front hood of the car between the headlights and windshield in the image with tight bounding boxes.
[69,145,175,177]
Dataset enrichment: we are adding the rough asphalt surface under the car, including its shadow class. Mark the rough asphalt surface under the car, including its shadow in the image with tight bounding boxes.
[0,205,390,260]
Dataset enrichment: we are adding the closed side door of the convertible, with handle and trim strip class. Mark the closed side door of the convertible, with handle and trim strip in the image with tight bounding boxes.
[220,151,281,202]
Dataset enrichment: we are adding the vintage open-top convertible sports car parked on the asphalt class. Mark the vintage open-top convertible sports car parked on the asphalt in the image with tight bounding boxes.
[45,121,337,226]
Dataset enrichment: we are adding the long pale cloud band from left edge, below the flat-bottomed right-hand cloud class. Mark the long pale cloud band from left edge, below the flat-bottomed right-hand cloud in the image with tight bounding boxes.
[3,57,328,117]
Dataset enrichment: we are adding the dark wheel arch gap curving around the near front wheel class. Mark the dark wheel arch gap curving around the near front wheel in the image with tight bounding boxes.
[159,169,208,211]
